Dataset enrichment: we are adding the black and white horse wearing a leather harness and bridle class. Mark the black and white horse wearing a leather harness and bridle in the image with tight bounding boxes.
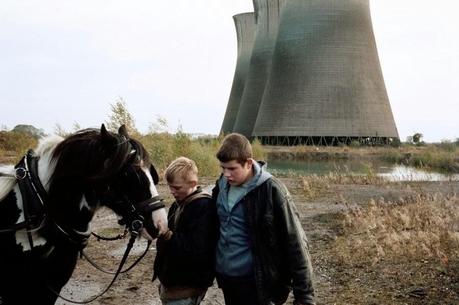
[0,125,167,305]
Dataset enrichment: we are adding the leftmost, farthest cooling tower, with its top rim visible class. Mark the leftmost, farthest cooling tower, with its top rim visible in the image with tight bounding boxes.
[221,13,255,134]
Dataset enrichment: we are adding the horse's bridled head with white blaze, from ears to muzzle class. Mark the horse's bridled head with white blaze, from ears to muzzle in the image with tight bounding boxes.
[96,125,164,238]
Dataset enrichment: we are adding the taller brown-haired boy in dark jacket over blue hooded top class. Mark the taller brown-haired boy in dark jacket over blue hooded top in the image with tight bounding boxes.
[212,133,315,305]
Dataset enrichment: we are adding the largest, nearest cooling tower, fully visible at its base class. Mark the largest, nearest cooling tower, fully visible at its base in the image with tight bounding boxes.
[252,0,398,144]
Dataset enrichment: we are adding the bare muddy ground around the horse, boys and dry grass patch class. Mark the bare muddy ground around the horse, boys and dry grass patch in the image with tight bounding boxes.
[57,178,459,305]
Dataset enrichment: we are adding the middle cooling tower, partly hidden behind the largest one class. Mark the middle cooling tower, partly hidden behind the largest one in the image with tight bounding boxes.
[234,0,286,137]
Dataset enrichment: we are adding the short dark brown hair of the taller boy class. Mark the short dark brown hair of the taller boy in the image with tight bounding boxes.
[217,133,252,164]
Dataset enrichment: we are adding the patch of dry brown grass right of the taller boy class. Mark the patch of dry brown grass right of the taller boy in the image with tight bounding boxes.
[335,195,459,266]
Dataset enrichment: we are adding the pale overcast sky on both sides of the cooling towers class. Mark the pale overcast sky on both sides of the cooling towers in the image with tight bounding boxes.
[0,0,459,142]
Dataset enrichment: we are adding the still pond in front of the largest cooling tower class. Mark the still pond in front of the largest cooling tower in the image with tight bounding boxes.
[268,160,459,181]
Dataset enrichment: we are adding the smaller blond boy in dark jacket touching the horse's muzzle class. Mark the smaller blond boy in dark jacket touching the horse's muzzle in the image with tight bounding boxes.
[153,157,216,305]
